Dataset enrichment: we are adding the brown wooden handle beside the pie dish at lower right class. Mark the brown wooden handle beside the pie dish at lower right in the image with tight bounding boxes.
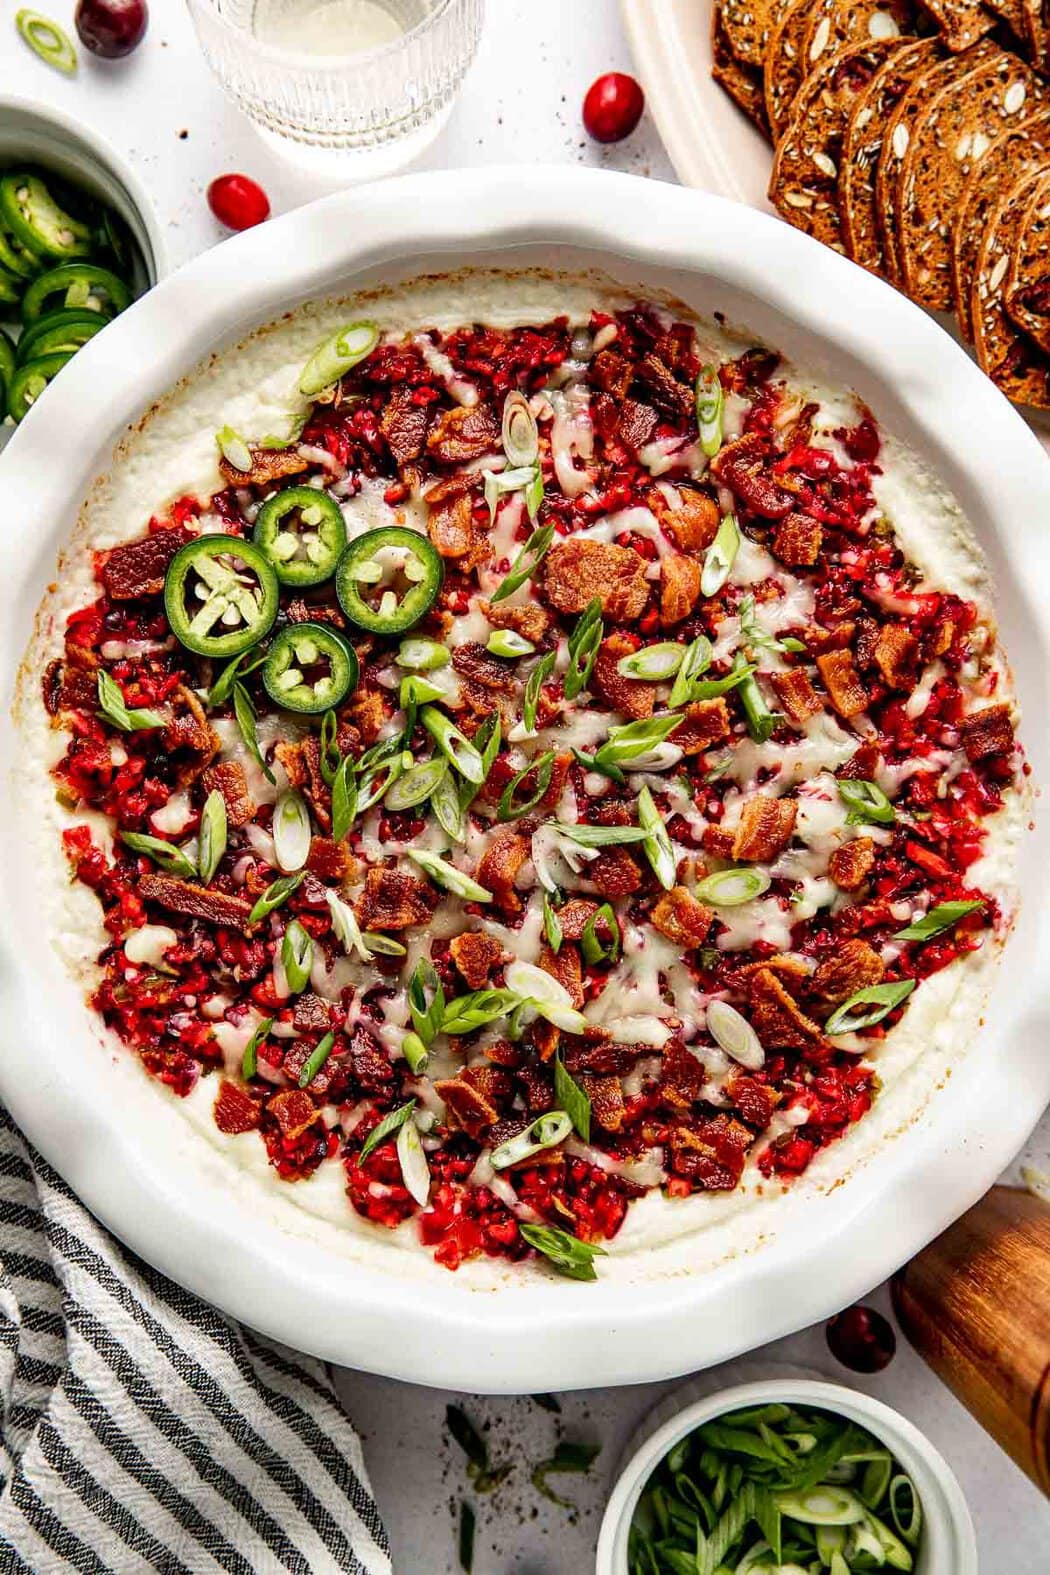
[893,1186,1050,1495]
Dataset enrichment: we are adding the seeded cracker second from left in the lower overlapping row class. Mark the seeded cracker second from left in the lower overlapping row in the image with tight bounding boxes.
[839,38,943,274]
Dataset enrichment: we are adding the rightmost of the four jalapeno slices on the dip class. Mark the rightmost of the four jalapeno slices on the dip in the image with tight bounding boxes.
[335,524,444,635]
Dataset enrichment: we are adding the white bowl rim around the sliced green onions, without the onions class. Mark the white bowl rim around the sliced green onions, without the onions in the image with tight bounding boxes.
[595,1378,978,1575]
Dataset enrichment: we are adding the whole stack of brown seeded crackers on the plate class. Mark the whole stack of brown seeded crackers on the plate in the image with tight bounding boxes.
[713,0,1050,410]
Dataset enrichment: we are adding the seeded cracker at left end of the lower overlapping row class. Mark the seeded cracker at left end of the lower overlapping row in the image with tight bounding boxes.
[770,38,902,252]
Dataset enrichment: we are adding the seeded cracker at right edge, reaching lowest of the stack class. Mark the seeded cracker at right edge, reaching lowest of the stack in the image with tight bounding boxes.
[971,160,1050,410]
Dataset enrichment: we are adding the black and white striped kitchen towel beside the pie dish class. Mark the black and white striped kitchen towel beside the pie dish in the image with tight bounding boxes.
[0,1109,390,1575]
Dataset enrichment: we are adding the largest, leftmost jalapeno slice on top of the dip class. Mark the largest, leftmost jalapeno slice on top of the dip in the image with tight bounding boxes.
[164,536,280,657]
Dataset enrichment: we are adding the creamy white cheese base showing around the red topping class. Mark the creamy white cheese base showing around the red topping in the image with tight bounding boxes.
[16,271,1026,1288]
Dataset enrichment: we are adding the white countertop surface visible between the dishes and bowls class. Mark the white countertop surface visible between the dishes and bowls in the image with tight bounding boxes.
[8,0,1050,1575]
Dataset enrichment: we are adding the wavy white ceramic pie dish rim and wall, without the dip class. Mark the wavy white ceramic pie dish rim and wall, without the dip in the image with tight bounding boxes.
[0,169,1050,1391]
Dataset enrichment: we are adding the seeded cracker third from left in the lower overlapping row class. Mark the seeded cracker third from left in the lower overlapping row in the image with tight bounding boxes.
[897,50,1045,310]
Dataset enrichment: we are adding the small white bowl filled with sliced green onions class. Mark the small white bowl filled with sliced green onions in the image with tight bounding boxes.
[597,1378,978,1575]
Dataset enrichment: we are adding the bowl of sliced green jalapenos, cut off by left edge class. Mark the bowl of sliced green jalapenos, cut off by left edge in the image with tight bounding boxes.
[0,98,164,428]
